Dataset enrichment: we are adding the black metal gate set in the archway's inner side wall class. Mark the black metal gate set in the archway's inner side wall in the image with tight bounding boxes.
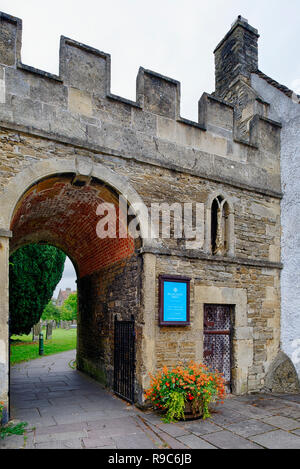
[114,317,135,403]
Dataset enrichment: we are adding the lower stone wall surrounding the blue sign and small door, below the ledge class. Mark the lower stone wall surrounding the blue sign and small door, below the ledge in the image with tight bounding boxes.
[155,256,280,393]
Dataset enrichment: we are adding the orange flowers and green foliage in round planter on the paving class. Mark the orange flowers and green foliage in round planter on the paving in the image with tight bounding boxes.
[145,361,225,422]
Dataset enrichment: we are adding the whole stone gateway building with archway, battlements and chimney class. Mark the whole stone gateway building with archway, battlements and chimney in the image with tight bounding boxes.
[0,13,298,418]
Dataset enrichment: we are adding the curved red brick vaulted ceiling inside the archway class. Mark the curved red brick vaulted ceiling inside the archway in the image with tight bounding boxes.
[11,175,134,278]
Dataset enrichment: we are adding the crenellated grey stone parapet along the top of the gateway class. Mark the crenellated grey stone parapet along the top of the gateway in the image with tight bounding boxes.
[0,13,280,196]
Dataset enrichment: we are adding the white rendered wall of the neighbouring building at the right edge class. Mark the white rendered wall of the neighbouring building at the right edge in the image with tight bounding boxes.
[252,74,300,376]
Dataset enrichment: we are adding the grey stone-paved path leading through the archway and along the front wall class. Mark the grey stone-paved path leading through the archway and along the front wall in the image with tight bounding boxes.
[0,351,300,449]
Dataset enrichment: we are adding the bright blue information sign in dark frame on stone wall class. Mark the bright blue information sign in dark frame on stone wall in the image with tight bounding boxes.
[160,275,190,326]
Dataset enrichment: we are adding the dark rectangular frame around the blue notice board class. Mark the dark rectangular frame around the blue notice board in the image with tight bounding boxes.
[159,275,191,327]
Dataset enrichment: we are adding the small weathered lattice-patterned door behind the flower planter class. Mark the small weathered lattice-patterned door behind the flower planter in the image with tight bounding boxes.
[203,305,233,392]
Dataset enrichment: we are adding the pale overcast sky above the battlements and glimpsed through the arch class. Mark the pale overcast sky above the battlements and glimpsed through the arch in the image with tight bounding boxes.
[0,0,300,296]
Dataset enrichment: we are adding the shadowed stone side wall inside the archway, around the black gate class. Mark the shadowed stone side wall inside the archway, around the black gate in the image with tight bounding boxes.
[76,250,142,393]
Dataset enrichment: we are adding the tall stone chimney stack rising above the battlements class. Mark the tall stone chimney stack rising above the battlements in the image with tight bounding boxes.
[214,16,259,98]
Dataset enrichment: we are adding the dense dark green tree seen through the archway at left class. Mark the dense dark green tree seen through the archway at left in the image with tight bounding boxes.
[9,244,66,335]
